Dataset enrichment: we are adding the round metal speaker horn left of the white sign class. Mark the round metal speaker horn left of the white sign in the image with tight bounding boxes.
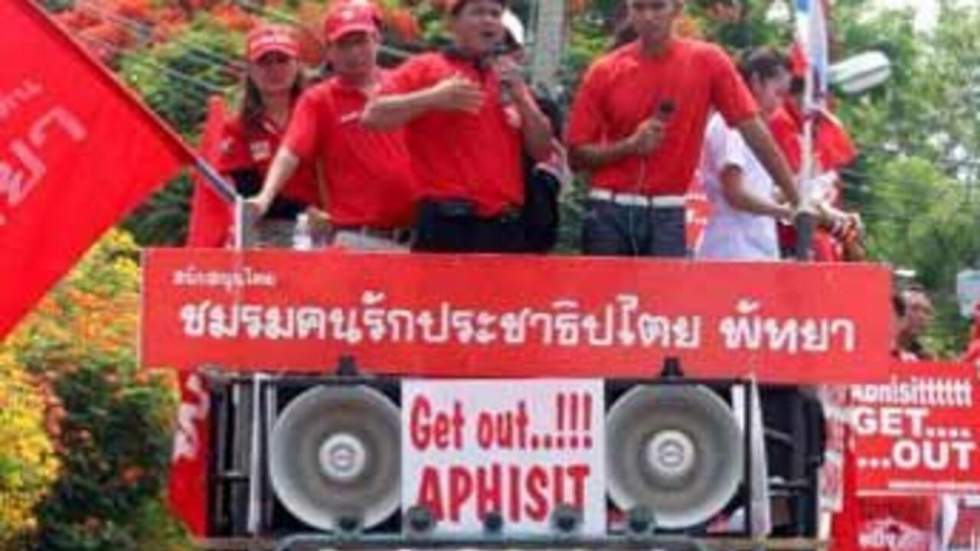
[269,386,401,531]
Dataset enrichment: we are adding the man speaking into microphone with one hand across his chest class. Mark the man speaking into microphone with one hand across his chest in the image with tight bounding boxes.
[362,0,551,252]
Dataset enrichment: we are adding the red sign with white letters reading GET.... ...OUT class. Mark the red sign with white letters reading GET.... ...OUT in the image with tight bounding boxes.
[851,362,980,495]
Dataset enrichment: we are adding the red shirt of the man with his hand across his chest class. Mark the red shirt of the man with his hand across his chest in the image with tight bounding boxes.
[385,53,524,216]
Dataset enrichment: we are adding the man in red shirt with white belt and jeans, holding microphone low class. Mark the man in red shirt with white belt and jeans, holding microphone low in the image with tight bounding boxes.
[568,0,798,256]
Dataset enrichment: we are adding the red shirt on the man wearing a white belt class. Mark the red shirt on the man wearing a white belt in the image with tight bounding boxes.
[568,38,758,195]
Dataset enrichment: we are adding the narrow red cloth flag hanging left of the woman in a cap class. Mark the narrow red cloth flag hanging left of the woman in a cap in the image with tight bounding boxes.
[187,96,232,247]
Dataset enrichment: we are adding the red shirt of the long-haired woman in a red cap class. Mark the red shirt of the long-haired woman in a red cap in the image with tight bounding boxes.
[216,117,320,205]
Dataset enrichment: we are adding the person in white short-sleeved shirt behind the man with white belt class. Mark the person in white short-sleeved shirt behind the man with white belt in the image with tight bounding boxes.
[696,48,793,260]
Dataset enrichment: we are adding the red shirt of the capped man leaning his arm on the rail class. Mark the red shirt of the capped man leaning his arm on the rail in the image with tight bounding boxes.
[284,73,415,229]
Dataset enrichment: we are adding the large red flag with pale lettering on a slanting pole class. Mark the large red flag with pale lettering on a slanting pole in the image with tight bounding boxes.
[0,0,192,337]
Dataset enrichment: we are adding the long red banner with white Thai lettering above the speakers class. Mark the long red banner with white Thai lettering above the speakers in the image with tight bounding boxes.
[141,249,891,382]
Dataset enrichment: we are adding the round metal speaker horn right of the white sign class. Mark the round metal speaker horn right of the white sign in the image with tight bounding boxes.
[606,385,745,530]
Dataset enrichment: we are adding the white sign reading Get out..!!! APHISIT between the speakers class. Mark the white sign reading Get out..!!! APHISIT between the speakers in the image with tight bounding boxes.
[402,379,606,535]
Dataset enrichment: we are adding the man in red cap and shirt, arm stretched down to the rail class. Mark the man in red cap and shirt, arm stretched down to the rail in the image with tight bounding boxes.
[251,2,415,250]
